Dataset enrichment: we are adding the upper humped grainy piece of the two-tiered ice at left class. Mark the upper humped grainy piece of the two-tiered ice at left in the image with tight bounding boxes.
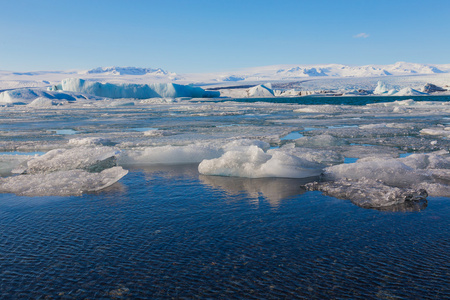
[15,147,120,174]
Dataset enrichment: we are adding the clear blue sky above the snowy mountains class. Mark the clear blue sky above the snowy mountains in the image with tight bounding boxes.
[0,0,450,73]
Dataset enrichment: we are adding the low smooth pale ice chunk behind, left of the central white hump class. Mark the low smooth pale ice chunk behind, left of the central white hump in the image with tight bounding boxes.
[118,144,223,166]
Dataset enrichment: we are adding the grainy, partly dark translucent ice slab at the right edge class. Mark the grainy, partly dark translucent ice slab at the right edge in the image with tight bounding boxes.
[307,151,450,207]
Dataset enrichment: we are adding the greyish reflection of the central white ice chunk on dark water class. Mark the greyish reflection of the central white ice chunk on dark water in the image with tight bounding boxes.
[199,175,317,208]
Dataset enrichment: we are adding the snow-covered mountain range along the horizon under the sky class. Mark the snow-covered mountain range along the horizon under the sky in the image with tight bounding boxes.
[0,62,450,90]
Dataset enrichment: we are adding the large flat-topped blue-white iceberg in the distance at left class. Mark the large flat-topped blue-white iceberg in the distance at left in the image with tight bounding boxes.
[51,78,220,99]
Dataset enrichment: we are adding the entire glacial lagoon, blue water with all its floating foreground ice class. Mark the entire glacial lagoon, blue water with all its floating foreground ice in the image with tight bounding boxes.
[0,96,450,299]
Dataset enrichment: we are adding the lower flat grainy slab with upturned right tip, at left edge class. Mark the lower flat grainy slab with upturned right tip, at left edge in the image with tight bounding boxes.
[0,167,128,196]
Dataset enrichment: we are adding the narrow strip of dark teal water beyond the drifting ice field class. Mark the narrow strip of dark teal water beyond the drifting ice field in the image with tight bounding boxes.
[216,96,450,105]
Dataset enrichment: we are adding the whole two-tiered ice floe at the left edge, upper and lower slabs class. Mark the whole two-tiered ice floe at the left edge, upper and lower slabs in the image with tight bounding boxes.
[0,147,128,196]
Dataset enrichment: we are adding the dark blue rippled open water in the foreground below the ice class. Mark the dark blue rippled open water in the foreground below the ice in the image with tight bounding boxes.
[0,166,450,299]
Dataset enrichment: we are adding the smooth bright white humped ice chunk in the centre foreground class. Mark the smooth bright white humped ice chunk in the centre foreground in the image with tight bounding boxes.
[198,145,324,178]
